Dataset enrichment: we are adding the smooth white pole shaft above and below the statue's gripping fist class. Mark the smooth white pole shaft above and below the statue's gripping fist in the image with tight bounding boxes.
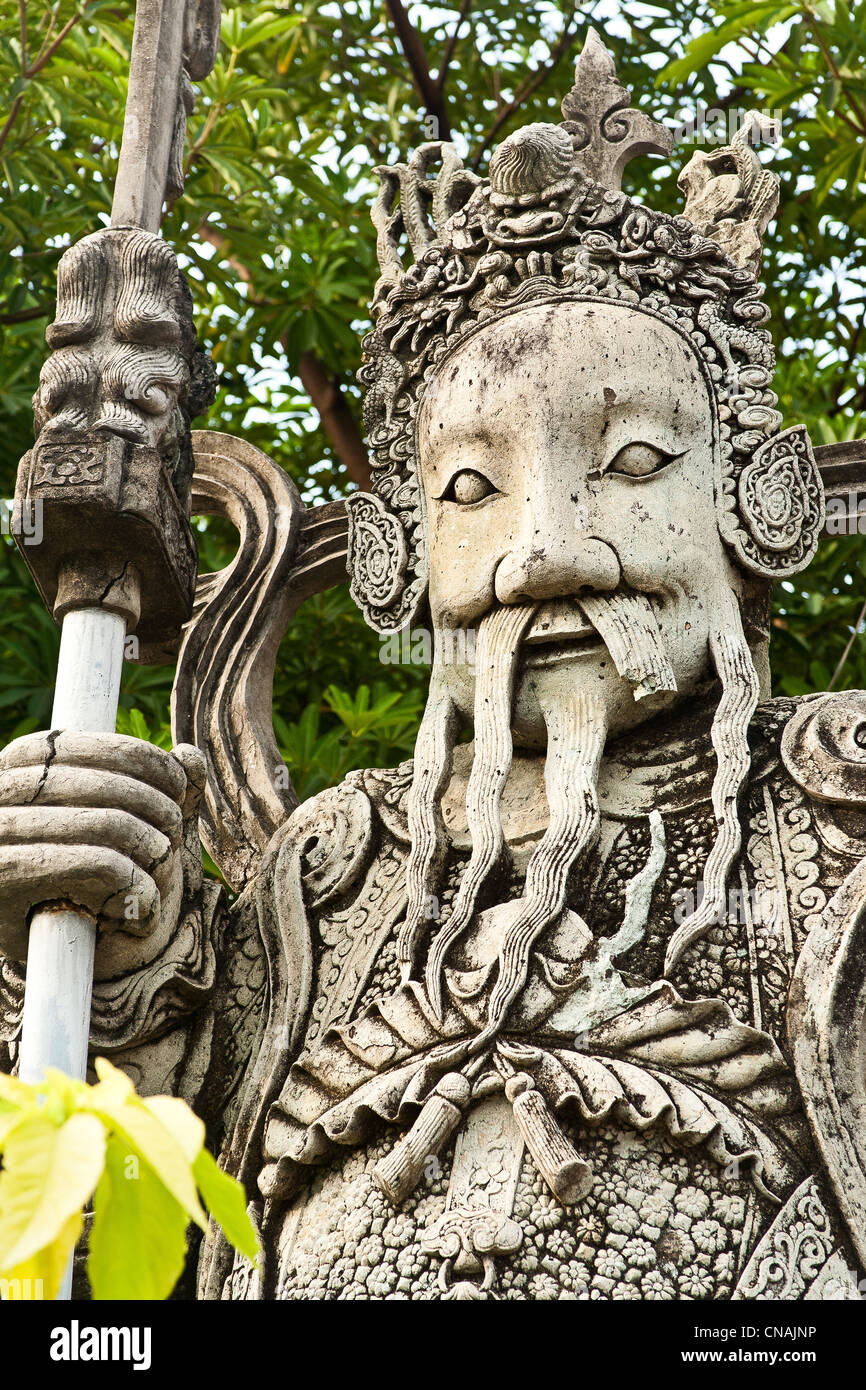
[18,609,126,1300]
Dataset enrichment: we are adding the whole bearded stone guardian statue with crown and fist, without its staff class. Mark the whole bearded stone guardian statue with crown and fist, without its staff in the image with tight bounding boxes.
[0,27,866,1300]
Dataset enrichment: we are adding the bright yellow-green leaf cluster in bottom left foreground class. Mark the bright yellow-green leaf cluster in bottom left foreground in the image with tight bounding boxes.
[0,1058,259,1300]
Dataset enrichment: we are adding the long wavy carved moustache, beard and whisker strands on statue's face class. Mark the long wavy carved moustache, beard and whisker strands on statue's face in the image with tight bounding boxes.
[398,589,758,1049]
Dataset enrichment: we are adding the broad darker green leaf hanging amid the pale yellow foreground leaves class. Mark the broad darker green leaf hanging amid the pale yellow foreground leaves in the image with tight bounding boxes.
[88,1136,189,1301]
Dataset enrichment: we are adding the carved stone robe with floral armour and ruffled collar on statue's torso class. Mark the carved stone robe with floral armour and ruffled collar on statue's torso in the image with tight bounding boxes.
[4,696,866,1300]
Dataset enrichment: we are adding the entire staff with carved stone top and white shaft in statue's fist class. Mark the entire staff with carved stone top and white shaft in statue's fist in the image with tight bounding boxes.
[15,0,220,1298]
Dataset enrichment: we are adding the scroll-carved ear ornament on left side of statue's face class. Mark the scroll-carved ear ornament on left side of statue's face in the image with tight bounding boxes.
[346,492,409,632]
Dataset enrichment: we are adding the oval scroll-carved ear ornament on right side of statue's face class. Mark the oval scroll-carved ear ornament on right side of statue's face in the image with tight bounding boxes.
[733,425,824,580]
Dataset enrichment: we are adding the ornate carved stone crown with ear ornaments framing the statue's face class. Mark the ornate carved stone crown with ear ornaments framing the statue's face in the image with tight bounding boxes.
[348,31,823,632]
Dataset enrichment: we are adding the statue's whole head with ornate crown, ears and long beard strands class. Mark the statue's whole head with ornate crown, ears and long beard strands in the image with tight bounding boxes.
[349,33,823,1034]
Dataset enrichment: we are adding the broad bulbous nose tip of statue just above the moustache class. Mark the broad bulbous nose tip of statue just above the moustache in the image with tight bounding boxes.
[495,537,620,603]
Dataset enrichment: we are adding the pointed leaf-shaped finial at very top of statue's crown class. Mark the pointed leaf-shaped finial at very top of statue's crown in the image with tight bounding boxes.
[562,29,674,193]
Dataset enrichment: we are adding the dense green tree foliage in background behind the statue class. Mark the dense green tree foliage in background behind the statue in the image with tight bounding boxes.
[0,0,866,795]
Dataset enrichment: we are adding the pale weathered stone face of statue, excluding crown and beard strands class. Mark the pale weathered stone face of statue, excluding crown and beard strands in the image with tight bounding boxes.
[418,302,737,744]
